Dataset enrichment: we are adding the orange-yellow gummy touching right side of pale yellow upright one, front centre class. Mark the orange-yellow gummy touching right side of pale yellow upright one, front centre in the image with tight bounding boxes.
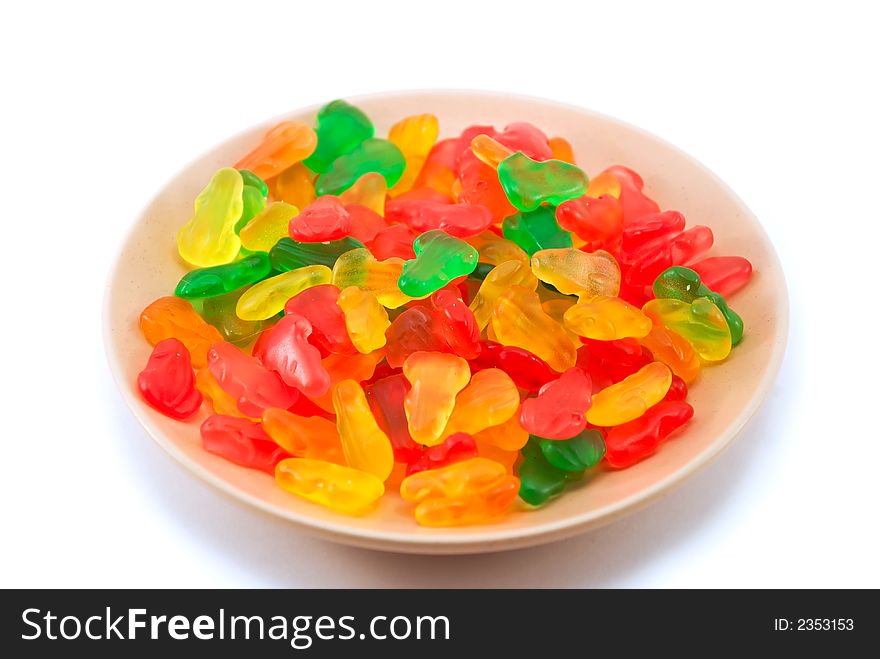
[443,368,519,437]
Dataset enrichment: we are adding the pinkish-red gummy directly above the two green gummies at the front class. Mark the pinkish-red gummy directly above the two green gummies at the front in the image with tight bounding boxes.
[519,367,592,439]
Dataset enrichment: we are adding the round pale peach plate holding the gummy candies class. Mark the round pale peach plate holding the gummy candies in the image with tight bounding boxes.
[104,91,788,554]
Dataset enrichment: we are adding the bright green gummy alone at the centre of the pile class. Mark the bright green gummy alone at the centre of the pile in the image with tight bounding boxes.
[397,229,479,297]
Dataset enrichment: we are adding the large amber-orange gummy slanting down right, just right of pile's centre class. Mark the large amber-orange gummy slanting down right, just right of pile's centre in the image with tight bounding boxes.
[492,286,577,373]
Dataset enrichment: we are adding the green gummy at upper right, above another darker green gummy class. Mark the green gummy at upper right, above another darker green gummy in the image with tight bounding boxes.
[498,151,590,211]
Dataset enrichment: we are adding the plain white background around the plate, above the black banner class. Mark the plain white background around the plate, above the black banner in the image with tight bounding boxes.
[0,0,880,587]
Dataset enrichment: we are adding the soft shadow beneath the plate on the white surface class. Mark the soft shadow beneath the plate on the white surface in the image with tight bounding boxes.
[107,346,801,588]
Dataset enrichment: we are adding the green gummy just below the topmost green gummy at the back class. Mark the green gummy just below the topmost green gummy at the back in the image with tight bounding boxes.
[315,138,406,197]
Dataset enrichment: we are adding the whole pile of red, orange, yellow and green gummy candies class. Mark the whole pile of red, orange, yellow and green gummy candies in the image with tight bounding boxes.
[138,101,751,526]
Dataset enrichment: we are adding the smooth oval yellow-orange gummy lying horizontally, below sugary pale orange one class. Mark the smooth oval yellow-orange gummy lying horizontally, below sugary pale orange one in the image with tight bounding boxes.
[563,295,653,341]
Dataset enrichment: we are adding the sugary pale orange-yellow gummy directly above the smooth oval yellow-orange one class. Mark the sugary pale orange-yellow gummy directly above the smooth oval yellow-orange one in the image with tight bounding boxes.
[531,247,620,297]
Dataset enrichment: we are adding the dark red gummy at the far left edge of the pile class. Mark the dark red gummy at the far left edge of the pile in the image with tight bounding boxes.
[138,338,202,419]
